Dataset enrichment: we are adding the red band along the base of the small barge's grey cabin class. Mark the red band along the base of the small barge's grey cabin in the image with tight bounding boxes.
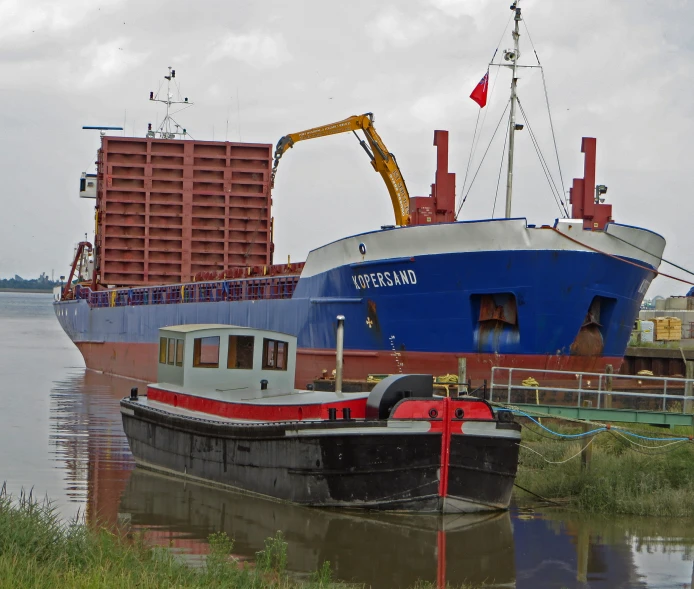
[147,386,366,421]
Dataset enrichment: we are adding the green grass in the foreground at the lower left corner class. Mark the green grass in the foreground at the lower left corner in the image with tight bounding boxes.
[0,489,346,589]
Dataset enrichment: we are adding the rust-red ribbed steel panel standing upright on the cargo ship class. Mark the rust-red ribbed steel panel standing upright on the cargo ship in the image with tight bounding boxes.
[96,137,273,286]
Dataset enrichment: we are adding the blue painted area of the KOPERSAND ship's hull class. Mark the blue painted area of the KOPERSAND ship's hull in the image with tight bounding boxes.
[55,250,653,357]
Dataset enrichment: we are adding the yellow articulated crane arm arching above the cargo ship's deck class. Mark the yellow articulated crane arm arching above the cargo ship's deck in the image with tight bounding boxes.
[270,112,410,225]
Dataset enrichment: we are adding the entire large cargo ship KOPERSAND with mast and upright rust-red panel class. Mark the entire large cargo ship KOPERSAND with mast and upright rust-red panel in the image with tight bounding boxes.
[54,4,665,387]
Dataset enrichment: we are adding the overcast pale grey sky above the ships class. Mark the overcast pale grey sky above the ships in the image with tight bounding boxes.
[0,0,694,296]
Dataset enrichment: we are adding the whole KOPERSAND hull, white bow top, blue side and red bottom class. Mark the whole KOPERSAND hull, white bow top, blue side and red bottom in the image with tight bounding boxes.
[56,219,664,386]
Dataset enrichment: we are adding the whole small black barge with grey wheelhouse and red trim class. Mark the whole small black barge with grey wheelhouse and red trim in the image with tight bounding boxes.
[121,325,520,513]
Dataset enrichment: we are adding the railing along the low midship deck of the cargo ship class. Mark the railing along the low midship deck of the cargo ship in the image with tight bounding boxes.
[74,276,299,307]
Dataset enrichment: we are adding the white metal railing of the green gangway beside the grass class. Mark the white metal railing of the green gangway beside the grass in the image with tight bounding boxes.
[489,366,694,413]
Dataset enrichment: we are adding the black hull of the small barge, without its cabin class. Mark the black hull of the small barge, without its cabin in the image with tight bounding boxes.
[121,399,519,513]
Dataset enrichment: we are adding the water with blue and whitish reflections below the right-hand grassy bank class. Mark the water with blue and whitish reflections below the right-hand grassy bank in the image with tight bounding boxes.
[513,510,694,589]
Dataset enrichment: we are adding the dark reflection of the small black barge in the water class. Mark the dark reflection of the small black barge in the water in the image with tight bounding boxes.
[119,468,515,589]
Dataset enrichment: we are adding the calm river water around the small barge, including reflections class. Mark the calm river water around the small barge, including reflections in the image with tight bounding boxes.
[0,293,694,589]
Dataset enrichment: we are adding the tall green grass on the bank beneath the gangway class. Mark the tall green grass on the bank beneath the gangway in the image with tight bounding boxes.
[516,422,694,517]
